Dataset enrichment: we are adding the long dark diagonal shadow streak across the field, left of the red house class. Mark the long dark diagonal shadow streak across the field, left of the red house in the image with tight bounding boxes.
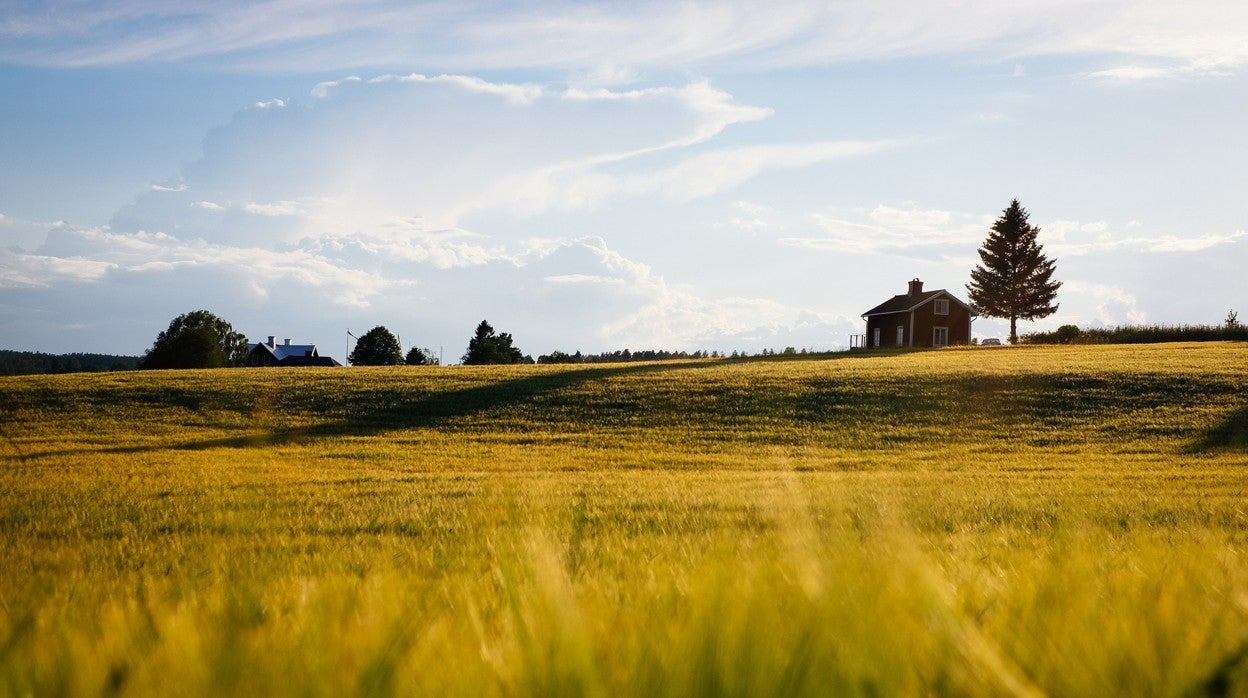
[168,362,716,451]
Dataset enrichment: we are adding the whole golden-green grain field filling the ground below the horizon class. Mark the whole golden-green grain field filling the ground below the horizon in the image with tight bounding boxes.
[0,342,1248,697]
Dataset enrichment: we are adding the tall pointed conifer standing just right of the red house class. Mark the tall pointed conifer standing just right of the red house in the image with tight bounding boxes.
[966,199,1062,343]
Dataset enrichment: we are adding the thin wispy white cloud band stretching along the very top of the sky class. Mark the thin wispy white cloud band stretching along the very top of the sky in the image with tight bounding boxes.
[9,0,1248,81]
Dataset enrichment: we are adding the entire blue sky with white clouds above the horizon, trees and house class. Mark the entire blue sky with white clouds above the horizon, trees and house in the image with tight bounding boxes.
[0,0,1248,363]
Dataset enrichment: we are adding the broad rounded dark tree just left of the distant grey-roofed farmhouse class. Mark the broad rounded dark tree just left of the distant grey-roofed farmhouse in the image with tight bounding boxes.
[139,310,247,368]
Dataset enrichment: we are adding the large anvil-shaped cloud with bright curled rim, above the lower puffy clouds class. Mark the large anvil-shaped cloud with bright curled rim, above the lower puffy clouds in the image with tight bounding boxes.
[129,74,858,233]
